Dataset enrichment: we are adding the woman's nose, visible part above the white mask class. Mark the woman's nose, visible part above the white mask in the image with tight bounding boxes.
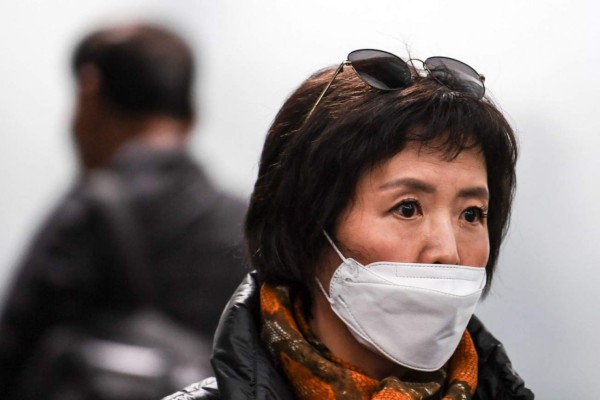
[421,221,460,265]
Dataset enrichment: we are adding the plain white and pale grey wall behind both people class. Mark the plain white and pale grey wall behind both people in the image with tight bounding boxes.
[0,0,600,399]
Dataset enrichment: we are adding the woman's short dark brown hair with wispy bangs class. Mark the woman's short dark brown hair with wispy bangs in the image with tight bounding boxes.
[245,63,517,298]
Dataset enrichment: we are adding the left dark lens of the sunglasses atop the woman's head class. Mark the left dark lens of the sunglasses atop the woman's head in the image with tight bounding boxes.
[348,50,411,90]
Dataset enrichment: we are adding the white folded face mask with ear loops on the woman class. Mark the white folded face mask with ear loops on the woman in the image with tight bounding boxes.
[317,232,485,371]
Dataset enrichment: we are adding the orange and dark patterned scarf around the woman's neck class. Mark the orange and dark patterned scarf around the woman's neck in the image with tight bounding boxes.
[260,284,477,400]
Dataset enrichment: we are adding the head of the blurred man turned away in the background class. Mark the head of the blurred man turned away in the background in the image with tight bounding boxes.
[72,24,194,168]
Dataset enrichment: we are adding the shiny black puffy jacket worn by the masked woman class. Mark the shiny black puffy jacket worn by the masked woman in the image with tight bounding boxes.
[163,273,534,400]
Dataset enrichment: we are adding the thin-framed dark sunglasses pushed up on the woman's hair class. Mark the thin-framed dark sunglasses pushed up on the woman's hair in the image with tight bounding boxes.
[304,49,485,122]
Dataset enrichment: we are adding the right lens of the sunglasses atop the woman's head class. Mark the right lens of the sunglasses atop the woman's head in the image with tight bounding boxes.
[425,57,485,99]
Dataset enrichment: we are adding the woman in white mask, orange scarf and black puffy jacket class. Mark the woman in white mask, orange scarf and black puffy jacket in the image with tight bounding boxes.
[165,50,533,399]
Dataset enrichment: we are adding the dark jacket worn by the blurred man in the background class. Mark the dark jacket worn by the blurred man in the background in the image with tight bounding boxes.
[0,144,247,399]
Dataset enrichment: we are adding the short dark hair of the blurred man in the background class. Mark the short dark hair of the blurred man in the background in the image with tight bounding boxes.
[72,24,194,119]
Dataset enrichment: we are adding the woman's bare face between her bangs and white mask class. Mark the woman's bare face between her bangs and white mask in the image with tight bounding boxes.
[335,142,490,267]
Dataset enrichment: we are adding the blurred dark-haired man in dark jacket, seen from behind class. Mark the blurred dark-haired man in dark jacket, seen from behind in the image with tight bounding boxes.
[0,25,245,399]
